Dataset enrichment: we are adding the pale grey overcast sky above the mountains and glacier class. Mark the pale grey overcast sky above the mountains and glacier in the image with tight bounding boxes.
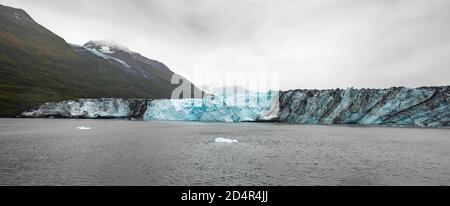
[0,0,450,89]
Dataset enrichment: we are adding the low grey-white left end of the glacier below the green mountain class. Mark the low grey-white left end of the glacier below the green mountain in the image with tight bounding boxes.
[19,98,148,119]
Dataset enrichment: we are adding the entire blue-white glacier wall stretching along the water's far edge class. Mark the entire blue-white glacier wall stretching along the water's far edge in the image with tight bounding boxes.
[18,86,450,127]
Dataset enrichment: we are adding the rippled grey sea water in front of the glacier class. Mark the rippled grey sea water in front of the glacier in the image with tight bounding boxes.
[0,119,450,185]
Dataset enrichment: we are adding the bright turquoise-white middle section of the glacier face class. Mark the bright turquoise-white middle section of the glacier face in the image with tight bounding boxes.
[144,91,278,122]
